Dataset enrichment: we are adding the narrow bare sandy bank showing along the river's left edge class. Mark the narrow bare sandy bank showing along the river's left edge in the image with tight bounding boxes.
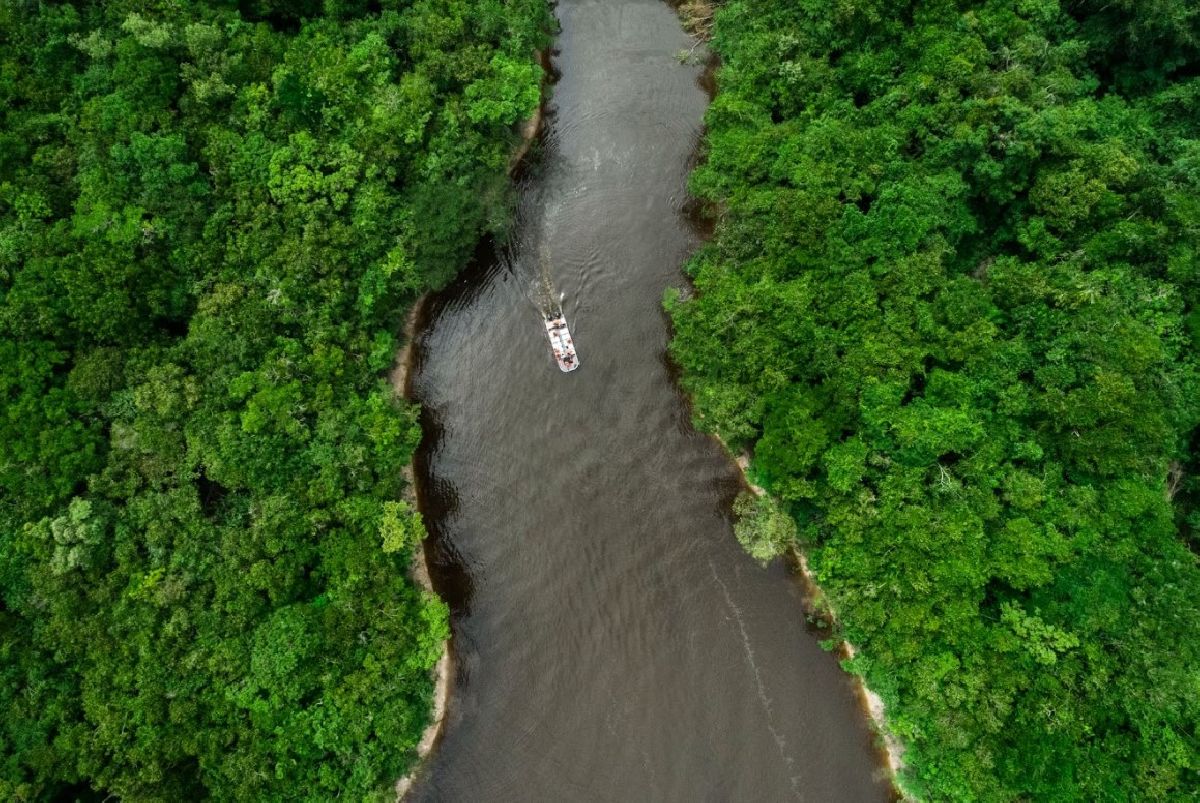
[388,50,552,801]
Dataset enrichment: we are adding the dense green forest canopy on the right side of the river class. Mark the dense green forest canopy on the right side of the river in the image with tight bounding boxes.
[667,0,1200,802]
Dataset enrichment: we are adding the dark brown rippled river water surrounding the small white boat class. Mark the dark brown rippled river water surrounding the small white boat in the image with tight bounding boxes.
[410,0,890,802]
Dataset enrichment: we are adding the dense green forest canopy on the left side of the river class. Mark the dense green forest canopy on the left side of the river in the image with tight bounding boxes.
[0,0,550,801]
